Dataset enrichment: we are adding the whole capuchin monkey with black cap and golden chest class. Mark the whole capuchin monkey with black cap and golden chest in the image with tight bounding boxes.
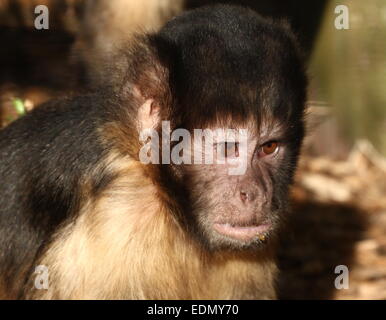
[0,5,307,299]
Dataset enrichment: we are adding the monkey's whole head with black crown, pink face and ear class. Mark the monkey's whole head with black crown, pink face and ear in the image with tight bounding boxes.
[119,6,307,249]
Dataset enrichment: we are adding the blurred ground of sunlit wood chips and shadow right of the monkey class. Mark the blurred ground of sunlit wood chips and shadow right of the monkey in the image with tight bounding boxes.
[279,141,386,299]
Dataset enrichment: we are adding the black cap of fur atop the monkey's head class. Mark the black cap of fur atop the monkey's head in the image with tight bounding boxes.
[157,6,306,128]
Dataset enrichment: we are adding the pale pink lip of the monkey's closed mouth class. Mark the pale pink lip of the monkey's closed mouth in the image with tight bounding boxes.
[213,223,271,241]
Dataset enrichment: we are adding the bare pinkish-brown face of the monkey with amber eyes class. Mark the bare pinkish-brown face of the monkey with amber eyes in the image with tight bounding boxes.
[176,120,293,249]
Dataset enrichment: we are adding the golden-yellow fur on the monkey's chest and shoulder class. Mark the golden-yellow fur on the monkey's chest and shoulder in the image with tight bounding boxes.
[27,151,276,299]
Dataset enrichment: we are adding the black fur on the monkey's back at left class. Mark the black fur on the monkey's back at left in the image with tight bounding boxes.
[0,95,115,296]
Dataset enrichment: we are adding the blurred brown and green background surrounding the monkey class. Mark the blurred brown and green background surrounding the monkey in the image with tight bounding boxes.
[0,0,386,299]
